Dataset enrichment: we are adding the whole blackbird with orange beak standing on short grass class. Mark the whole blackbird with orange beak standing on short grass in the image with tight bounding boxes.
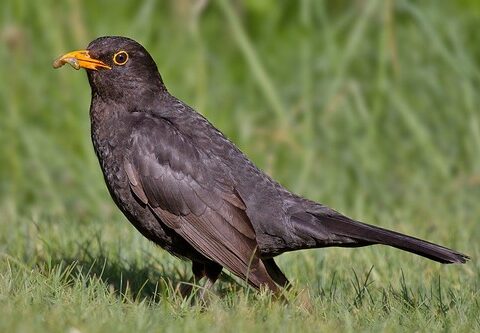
[53,36,469,292]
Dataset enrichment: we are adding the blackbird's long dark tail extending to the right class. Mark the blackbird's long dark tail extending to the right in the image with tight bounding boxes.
[292,207,470,264]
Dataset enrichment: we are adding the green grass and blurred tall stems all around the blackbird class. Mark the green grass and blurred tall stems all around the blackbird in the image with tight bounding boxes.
[0,0,480,333]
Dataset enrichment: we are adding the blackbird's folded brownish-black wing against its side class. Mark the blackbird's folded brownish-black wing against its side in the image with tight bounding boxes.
[124,118,270,287]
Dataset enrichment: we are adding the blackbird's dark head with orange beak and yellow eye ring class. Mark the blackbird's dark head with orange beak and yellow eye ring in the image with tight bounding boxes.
[53,36,165,101]
